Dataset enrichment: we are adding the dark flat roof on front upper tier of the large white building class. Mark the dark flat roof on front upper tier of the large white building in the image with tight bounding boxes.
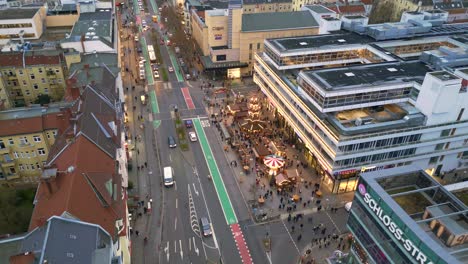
[301,62,431,90]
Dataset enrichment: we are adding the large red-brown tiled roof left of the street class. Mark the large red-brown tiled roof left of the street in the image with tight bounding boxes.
[29,137,125,237]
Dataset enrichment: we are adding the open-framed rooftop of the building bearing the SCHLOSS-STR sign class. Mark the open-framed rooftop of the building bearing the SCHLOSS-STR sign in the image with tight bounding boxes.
[361,166,468,263]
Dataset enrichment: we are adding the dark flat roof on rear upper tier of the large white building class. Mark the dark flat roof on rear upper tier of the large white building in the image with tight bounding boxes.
[266,33,375,52]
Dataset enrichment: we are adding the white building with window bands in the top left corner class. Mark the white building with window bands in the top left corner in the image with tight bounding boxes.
[0,7,45,40]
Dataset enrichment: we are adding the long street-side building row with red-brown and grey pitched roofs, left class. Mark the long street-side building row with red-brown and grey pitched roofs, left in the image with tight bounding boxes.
[30,55,130,263]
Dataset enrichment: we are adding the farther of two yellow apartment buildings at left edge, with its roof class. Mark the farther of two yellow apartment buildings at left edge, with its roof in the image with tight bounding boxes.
[0,50,67,109]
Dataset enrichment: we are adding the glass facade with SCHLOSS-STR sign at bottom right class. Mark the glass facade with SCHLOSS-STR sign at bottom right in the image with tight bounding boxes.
[347,178,447,264]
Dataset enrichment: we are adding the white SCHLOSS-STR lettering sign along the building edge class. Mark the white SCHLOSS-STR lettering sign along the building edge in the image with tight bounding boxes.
[358,184,433,264]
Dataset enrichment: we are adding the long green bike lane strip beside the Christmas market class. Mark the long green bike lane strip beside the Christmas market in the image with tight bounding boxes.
[192,118,237,225]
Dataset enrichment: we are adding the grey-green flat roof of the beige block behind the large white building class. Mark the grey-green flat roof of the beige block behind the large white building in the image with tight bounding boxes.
[242,11,319,32]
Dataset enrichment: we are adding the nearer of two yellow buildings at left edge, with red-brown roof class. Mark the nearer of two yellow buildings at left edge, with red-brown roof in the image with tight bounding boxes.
[0,103,70,186]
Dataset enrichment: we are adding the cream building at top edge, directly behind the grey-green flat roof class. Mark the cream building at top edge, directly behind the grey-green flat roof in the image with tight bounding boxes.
[242,0,293,14]
